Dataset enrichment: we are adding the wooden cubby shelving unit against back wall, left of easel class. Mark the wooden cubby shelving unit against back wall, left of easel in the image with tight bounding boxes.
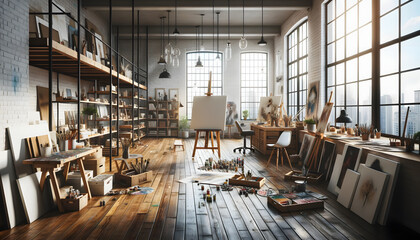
[148,101,179,137]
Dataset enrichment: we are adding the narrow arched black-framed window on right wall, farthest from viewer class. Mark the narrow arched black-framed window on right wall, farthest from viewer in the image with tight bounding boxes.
[287,21,308,120]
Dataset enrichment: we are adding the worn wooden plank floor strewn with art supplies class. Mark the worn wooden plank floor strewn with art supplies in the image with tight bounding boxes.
[0,139,416,239]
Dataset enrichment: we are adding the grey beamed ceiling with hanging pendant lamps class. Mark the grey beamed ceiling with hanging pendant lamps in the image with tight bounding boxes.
[83,0,312,38]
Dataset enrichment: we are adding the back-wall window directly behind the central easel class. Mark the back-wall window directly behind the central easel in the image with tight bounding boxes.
[186,52,223,119]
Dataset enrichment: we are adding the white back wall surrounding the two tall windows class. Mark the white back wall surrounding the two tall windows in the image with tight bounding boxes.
[144,39,274,116]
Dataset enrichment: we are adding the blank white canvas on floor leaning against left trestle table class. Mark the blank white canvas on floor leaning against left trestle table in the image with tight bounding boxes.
[16,172,54,223]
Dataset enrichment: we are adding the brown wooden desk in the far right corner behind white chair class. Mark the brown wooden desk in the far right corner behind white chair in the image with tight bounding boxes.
[251,124,299,155]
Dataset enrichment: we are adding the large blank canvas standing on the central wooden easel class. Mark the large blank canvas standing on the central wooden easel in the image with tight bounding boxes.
[191,96,227,130]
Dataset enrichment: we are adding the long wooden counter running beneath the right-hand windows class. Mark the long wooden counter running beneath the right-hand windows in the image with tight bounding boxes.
[299,130,420,233]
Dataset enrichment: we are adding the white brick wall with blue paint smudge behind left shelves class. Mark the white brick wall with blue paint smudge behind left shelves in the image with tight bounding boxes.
[0,0,108,150]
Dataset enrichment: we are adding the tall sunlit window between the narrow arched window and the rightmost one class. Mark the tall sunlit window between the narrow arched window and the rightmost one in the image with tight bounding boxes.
[326,0,372,126]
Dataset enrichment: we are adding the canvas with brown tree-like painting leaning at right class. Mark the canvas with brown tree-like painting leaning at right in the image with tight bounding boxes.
[351,164,389,224]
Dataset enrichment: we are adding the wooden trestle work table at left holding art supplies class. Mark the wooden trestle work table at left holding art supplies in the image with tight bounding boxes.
[23,147,100,212]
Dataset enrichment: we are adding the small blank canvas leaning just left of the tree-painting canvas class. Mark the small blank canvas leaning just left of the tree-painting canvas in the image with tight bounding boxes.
[337,169,360,208]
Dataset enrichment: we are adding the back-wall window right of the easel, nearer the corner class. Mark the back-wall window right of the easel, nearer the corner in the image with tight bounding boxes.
[241,52,268,119]
